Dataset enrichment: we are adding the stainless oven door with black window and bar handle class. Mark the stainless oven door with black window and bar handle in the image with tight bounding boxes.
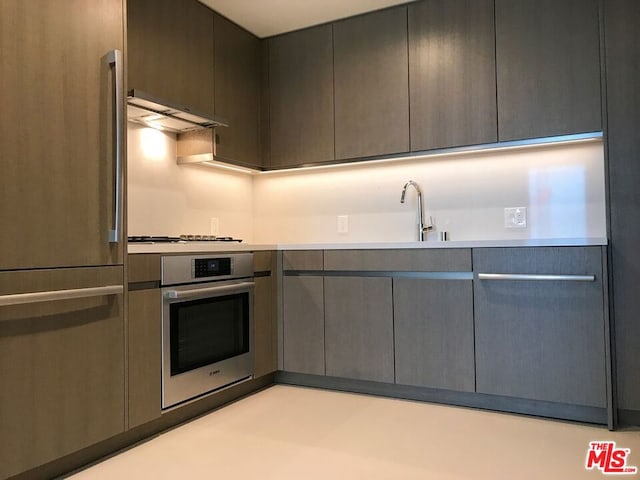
[162,280,254,409]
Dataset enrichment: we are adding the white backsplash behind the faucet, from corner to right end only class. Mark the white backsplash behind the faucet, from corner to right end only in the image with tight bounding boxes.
[254,141,606,243]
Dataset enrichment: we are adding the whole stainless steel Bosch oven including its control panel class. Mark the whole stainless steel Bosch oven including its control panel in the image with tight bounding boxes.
[162,253,254,409]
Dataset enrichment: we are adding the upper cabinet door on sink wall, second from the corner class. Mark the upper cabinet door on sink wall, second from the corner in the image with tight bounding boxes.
[333,6,409,159]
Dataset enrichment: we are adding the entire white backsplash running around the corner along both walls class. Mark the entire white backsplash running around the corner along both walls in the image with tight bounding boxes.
[128,124,606,243]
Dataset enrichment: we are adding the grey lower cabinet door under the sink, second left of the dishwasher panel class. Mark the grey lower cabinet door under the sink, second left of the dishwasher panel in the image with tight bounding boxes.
[325,277,394,383]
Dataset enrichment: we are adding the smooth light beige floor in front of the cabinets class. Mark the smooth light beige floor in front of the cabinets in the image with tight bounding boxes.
[69,385,640,480]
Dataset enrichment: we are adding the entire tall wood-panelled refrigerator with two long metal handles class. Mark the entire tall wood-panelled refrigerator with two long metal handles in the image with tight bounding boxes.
[0,0,125,478]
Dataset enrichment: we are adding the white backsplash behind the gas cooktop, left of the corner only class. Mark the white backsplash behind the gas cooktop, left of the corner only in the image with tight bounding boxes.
[127,123,253,242]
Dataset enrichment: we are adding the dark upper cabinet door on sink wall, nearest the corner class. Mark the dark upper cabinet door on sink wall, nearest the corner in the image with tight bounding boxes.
[265,25,335,167]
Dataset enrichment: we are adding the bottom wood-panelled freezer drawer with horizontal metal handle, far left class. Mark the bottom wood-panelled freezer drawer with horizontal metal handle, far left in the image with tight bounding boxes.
[0,267,125,478]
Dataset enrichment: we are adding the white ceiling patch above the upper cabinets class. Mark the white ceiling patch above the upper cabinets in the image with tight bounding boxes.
[200,0,407,38]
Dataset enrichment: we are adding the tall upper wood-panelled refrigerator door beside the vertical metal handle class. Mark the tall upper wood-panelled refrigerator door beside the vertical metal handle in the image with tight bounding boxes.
[0,0,124,270]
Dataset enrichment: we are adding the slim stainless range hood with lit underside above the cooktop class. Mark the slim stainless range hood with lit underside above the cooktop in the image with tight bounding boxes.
[127,90,229,133]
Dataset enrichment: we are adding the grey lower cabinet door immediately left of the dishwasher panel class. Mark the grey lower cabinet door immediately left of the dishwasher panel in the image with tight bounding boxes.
[393,278,475,392]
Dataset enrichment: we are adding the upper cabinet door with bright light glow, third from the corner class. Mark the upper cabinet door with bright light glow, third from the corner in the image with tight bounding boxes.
[408,0,497,151]
